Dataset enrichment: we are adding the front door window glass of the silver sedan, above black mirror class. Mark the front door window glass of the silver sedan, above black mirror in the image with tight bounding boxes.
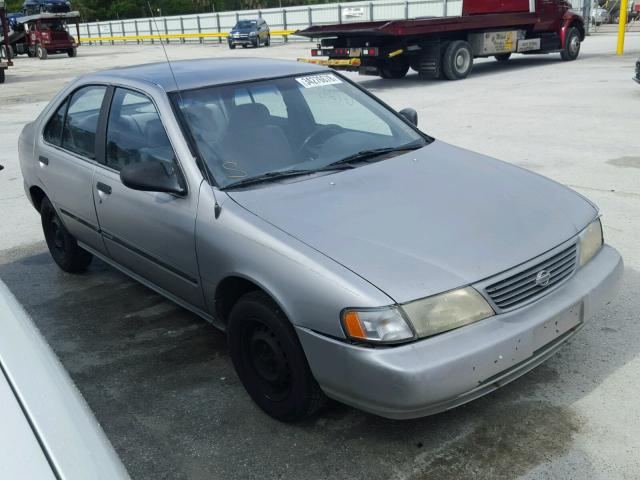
[105,88,175,171]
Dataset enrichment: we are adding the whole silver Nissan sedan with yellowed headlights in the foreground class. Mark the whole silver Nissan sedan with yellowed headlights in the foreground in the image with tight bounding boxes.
[19,58,623,421]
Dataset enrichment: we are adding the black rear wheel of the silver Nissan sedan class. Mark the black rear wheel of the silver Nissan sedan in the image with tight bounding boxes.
[40,197,93,273]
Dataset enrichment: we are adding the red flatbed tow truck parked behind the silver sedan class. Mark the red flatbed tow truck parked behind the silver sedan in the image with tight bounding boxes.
[296,0,585,80]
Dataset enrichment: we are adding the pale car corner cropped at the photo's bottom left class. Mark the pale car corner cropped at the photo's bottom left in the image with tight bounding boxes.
[0,280,129,480]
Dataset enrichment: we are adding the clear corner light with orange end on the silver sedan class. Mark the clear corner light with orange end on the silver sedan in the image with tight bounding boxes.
[342,307,415,343]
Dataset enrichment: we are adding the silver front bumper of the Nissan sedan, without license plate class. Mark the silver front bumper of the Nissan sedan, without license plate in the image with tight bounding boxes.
[297,245,624,419]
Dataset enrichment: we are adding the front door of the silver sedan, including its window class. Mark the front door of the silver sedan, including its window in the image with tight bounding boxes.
[93,88,204,308]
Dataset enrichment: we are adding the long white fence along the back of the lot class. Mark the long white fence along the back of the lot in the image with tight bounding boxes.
[80,0,590,45]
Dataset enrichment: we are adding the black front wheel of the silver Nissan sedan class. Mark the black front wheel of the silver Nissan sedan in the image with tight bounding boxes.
[227,291,326,422]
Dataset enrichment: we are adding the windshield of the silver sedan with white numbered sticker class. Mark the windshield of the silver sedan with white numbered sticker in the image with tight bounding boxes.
[172,73,427,188]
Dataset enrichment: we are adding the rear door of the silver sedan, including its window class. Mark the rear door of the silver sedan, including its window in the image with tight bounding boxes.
[36,85,107,252]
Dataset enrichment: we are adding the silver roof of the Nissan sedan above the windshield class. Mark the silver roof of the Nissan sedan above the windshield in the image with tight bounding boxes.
[83,58,328,92]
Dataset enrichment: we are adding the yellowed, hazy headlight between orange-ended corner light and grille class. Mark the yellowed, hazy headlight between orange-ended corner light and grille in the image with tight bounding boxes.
[402,287,494,337]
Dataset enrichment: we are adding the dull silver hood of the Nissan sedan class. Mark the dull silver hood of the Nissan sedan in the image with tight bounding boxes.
[228,141,597,303]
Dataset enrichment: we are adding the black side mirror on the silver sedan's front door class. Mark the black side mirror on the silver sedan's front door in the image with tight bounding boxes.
[120,161,186,195]
